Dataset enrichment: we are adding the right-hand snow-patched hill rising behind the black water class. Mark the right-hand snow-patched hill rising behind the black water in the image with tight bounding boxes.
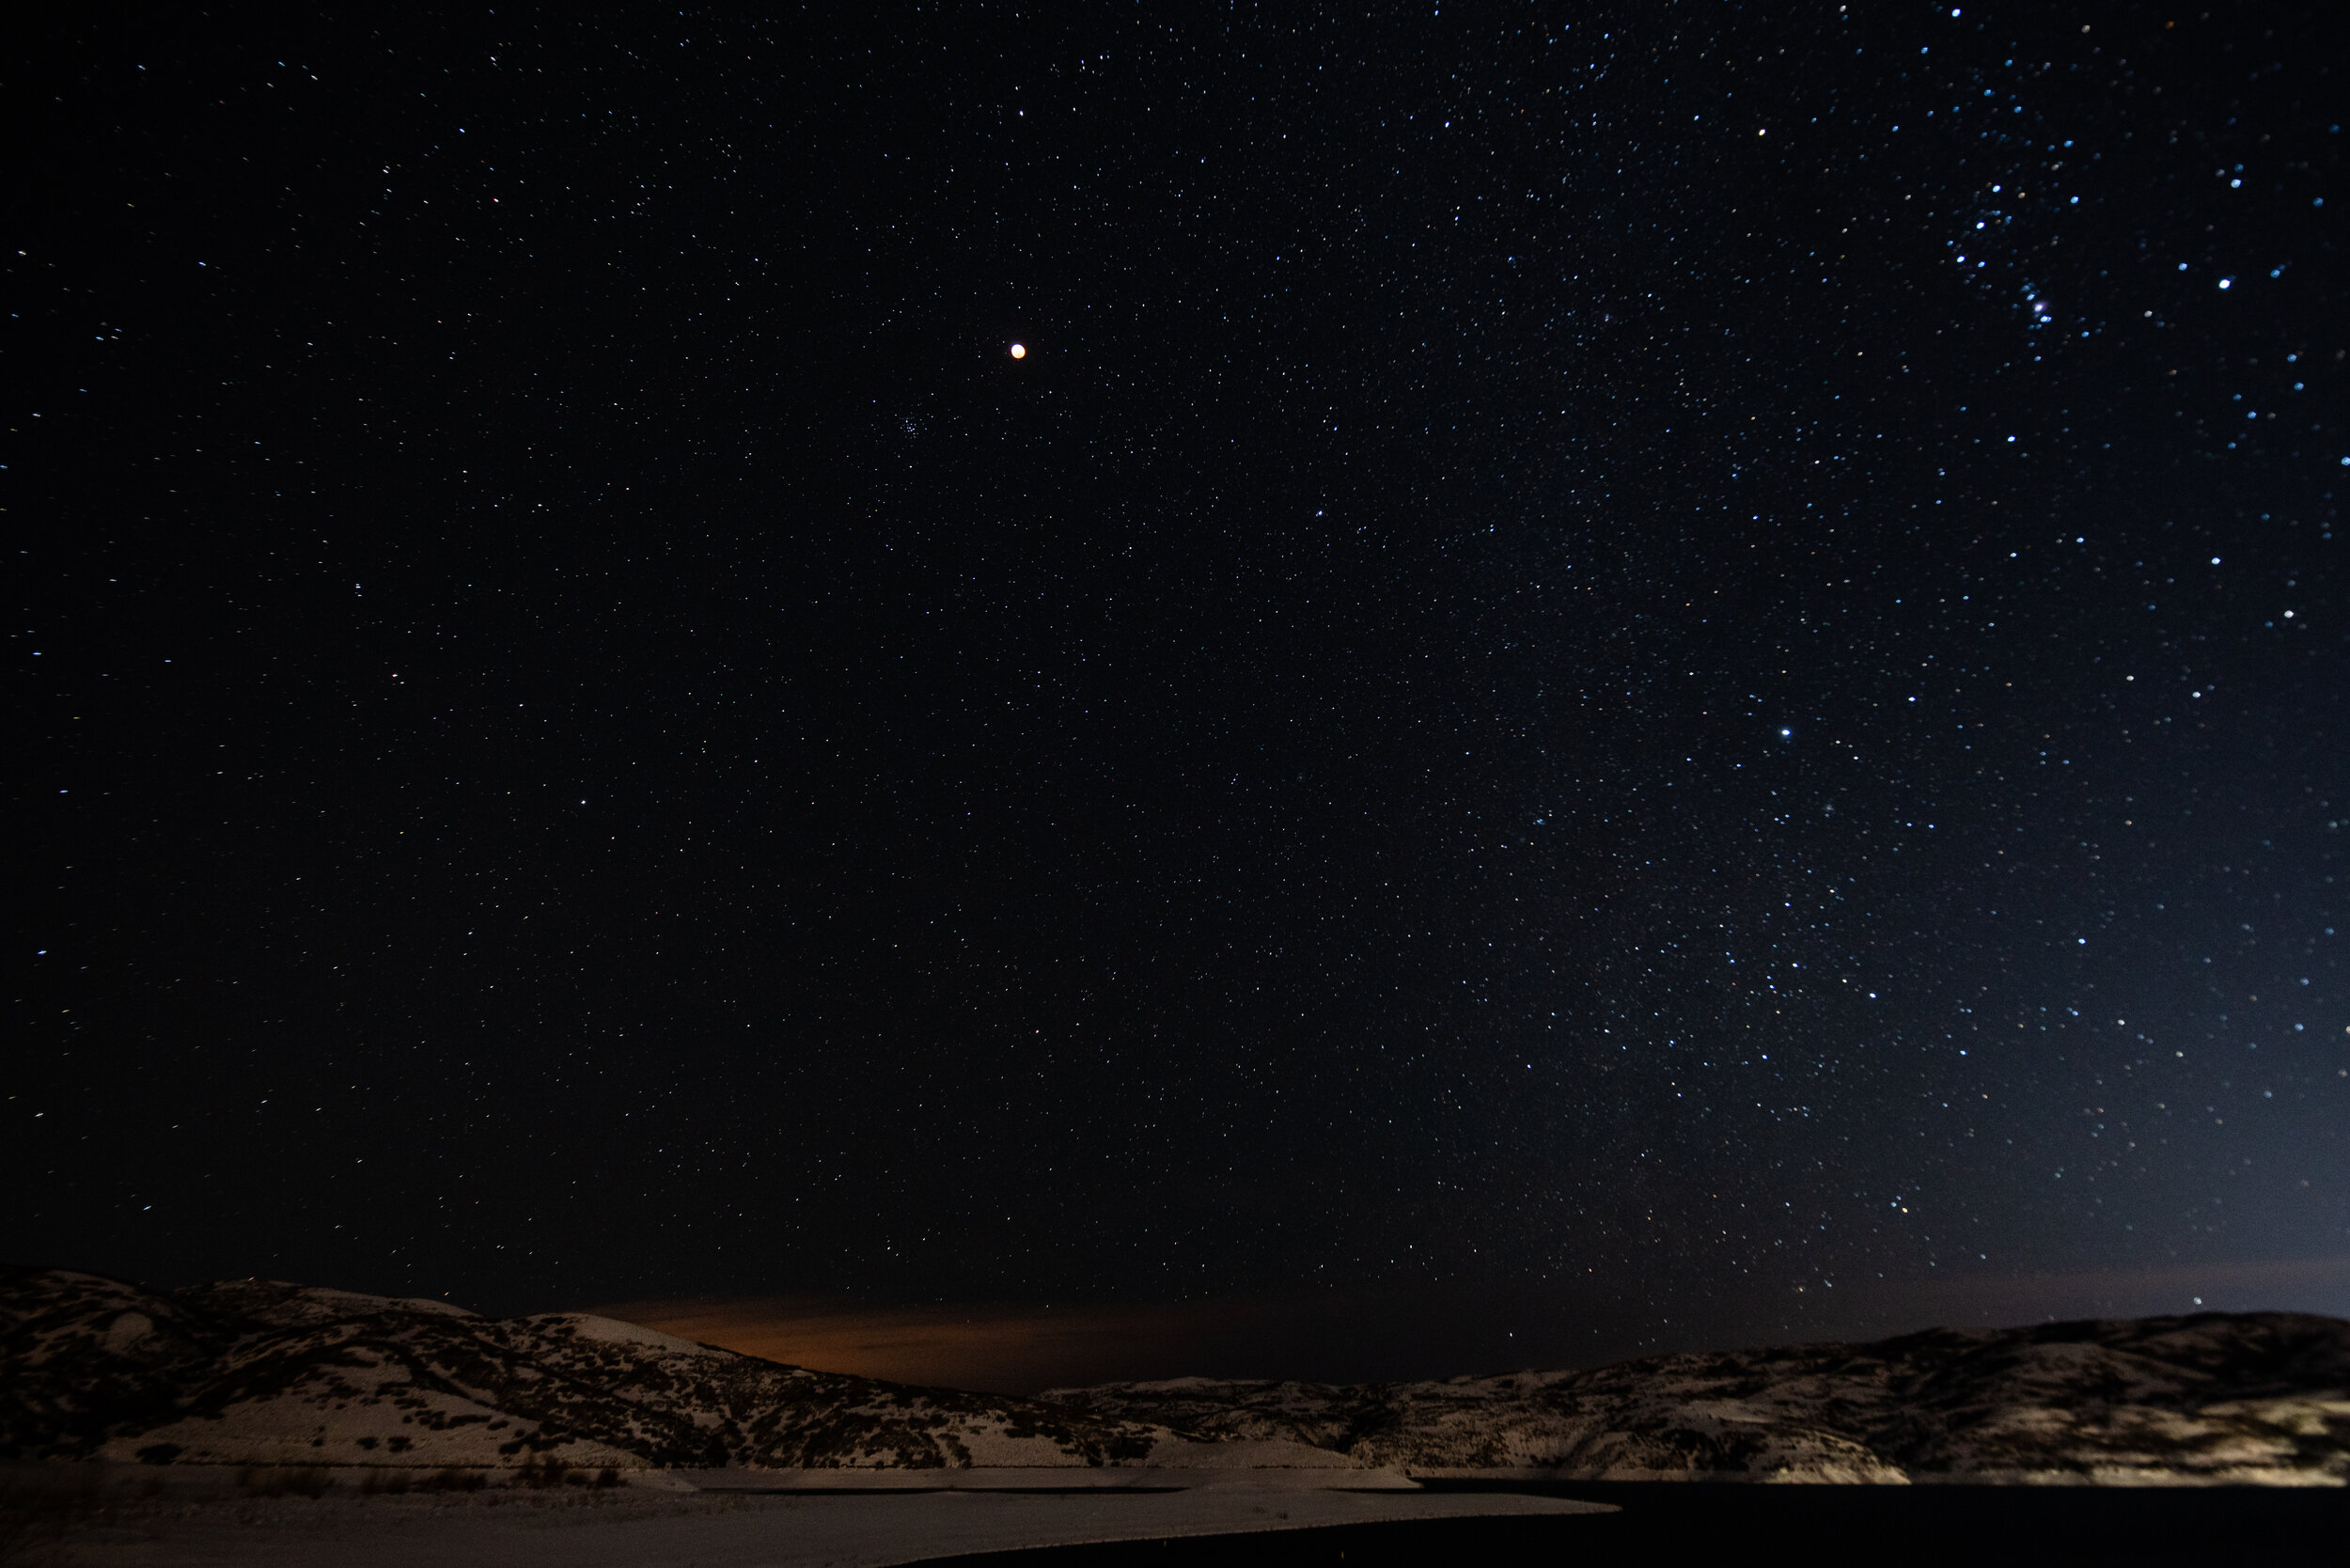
[1043,1311,2350,1485]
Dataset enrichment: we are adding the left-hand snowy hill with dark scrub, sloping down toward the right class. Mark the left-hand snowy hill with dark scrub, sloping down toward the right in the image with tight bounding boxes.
[0,1269,1352,1469]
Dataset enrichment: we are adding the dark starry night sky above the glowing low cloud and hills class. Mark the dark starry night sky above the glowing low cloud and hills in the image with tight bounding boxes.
[18,0,2350,1371]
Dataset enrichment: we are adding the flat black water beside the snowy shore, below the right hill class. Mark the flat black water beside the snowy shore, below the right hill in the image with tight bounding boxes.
[921,1481,2350,1568]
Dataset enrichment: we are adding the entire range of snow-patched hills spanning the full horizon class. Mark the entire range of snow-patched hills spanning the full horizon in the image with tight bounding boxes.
[0,1269,2350,1485]
